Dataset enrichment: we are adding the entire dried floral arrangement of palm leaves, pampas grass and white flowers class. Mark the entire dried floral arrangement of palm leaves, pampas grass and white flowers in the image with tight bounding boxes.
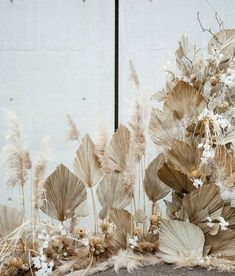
[0,18,235,275]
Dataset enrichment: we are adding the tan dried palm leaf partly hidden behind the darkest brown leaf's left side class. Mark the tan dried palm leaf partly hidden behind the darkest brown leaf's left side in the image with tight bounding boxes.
[144,154,171,202]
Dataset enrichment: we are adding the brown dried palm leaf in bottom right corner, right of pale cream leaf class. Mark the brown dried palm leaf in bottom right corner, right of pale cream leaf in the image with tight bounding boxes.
[205,229,235,257]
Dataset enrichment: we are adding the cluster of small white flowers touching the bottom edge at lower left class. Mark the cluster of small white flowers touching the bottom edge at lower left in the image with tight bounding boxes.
[32,230,54,276]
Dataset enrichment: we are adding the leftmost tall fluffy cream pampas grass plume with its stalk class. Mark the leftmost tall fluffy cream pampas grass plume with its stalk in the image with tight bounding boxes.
[1,109,32,213]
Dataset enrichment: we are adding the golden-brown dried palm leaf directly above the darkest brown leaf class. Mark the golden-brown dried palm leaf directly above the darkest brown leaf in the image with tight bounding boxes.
[165,140,201,177]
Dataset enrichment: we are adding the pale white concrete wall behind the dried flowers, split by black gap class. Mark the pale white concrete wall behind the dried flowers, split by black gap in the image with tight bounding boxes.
[0,0,235,226]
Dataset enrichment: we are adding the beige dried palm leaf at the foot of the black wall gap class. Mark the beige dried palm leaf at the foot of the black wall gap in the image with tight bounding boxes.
[108,125,131,172]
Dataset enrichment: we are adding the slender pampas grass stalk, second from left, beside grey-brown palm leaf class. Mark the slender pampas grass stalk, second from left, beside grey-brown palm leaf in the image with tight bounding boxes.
[32,136,50,231]
